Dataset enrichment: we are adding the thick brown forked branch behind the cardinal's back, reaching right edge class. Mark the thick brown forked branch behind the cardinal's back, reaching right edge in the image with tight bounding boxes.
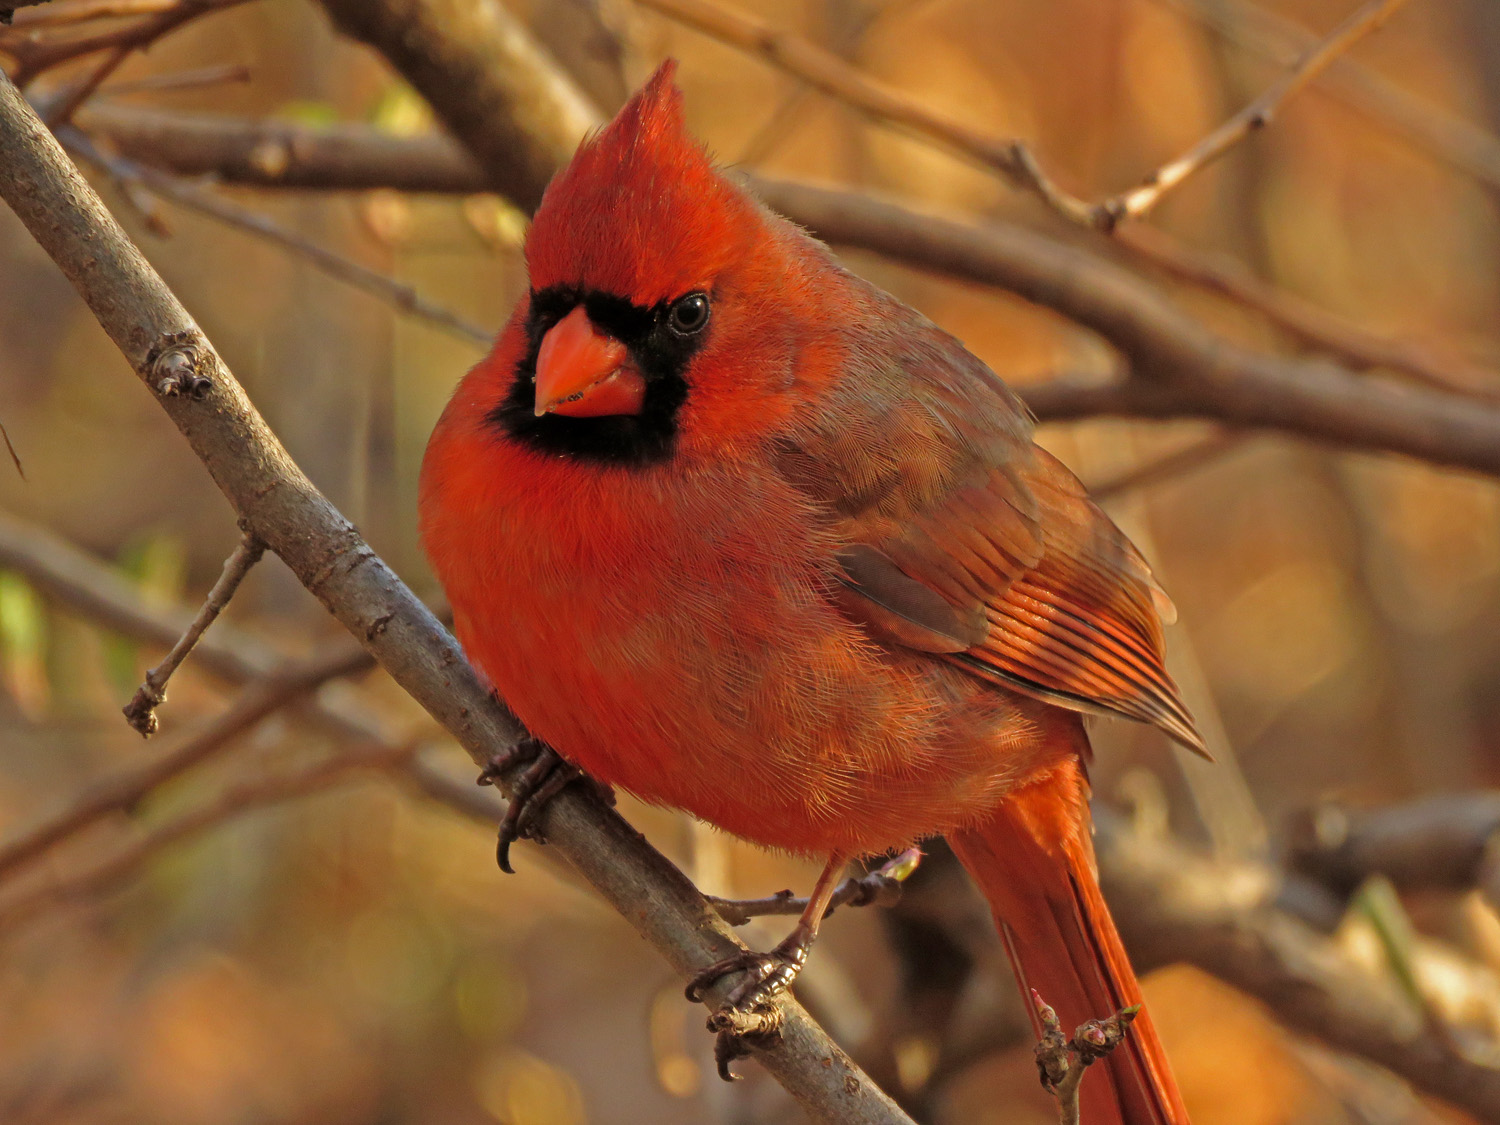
[755,180,1500,474]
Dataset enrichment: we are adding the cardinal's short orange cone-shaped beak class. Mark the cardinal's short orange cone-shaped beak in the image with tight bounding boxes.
[537,305,647,419]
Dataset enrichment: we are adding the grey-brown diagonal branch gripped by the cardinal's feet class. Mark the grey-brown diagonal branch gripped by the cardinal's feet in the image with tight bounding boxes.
[0,68,909,1125]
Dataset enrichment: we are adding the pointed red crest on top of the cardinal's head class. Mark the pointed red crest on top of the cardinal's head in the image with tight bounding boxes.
[527,59,759,308]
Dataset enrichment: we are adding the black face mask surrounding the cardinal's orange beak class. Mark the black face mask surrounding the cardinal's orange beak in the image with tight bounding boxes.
[489,287,708,467]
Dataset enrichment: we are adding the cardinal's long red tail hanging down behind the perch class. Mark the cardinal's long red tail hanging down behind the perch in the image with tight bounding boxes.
[948,761,1188,1125]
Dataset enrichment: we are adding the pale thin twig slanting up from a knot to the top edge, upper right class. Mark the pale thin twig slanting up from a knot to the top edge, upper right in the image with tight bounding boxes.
[1094,0,1406,231]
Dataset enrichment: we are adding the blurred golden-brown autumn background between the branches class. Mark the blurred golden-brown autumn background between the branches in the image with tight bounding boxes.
[0,0,1500,1125]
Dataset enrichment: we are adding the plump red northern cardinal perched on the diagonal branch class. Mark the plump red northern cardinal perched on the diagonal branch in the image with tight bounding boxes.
[420,62,1202,1125]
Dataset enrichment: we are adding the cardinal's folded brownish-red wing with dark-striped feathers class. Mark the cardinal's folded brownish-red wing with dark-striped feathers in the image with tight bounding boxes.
[780,334,1203,753]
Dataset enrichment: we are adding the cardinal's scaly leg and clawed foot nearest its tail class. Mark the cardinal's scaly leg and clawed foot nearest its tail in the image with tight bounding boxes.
[687,855,848,1082]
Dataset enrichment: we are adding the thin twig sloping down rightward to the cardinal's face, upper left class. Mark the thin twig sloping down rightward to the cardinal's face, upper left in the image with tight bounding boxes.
[57,126,494,347]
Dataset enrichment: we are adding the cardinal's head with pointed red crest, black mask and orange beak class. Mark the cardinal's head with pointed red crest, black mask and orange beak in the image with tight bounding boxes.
[494,60,828,464]
